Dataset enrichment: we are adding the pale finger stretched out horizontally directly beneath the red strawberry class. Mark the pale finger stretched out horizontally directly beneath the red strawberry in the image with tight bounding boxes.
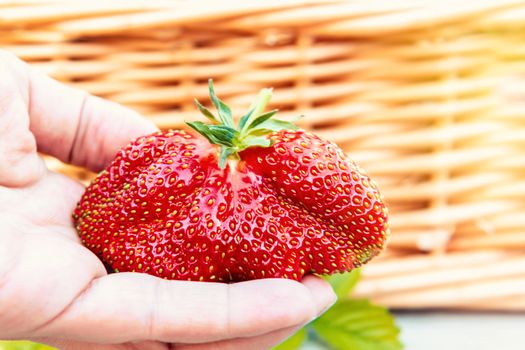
[34,273,335,343]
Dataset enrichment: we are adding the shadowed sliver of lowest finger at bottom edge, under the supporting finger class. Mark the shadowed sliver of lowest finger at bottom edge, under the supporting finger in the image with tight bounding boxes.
[175,327,301,350]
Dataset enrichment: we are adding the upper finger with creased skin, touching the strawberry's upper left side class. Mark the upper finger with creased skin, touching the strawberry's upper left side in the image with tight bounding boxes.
[2,53,157,171]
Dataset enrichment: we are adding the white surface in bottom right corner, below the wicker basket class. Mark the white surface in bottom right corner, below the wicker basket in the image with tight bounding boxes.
[396,312,525,350]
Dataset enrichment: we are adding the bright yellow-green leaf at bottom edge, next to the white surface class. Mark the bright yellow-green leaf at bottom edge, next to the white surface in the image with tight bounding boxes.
[312,300,403,350]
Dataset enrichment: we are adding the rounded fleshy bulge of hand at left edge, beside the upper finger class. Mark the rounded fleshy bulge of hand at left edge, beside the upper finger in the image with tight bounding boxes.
[0,51,45,186]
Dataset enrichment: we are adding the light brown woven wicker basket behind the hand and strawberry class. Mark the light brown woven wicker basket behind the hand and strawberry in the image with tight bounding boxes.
[4,0,525,310]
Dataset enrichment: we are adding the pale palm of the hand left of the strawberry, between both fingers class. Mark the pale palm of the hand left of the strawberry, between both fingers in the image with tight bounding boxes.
[0,51,149,345]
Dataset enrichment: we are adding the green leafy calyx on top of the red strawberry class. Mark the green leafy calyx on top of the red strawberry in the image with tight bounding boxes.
[186,79,299,169]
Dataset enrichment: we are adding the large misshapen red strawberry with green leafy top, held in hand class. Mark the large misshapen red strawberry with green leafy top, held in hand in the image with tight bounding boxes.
[73,81,388,282]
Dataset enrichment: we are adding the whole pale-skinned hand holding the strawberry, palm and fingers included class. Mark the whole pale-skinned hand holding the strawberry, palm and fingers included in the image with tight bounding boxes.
[0,51,335,350]
